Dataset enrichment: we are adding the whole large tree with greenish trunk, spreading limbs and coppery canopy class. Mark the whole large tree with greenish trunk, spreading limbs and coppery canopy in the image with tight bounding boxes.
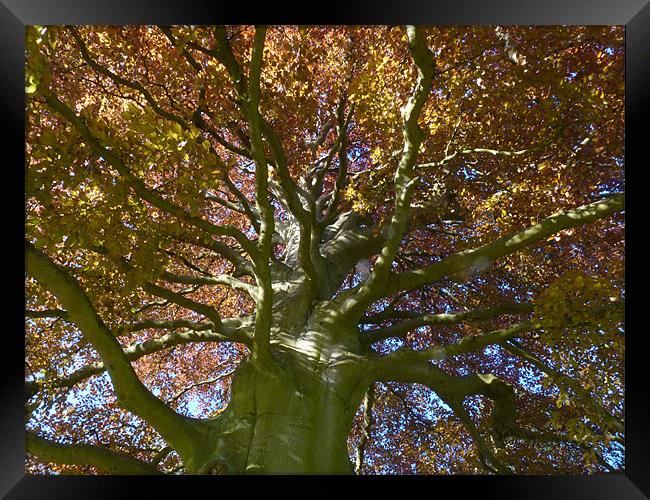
[25,26,624,474]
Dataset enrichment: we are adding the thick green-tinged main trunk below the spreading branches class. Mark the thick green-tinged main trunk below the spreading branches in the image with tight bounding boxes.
[191,314,370,474]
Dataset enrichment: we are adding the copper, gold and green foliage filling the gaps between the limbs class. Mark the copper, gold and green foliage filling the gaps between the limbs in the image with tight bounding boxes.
[26,26,624,474]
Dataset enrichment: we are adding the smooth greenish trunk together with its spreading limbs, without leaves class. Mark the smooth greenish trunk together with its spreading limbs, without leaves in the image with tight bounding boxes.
[25,27,625,474]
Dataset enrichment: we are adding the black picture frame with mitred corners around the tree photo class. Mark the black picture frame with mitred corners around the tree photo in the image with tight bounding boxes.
[0,0,650,499]
